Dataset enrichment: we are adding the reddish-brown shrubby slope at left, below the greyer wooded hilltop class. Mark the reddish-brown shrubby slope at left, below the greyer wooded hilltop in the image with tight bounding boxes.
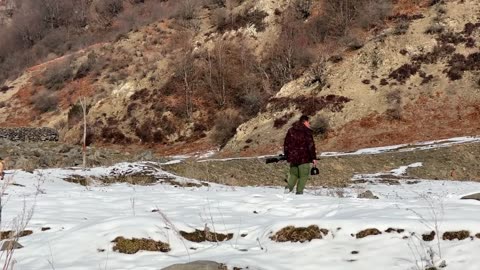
[0,1,286,154]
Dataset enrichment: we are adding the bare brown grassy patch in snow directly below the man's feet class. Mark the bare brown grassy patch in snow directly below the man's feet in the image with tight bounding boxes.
[270,225,328,243]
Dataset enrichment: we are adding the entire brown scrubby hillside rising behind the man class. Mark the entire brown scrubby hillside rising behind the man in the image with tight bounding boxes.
[0,0,480,154]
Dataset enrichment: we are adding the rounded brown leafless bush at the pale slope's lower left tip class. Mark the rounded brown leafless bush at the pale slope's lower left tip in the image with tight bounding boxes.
[211,109,243,147]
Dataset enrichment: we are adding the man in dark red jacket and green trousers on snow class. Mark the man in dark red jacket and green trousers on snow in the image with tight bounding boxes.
[283,115,317,194]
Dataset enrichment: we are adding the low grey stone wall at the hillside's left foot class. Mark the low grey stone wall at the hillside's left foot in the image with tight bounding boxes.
[0,127,58,142]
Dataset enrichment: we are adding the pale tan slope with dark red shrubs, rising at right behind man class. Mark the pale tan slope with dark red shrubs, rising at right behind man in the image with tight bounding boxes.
[226,0,480,155]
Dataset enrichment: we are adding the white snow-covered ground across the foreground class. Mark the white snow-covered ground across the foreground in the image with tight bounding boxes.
[0,158,480,270]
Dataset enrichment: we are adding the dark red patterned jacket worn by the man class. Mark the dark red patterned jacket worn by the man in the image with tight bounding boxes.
[283,121,317,165]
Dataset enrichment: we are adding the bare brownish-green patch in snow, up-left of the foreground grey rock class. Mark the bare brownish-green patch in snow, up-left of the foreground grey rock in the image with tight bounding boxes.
[112,236,170,254]
